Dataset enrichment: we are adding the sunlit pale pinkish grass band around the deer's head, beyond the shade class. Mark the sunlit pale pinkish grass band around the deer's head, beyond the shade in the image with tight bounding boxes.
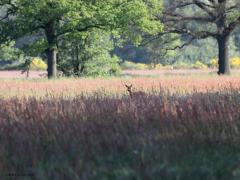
[0,76,240,98]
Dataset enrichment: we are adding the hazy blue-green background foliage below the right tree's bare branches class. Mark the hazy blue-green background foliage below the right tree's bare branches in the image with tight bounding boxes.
[115,36,240,68]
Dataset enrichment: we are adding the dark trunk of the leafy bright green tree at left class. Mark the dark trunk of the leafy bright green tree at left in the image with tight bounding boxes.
[45,22,57,79]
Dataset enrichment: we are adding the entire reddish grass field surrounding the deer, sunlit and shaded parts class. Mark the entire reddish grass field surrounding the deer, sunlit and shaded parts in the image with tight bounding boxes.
[0,71,240,180]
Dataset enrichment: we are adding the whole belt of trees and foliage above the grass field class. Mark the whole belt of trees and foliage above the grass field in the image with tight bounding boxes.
[0,0,240,78]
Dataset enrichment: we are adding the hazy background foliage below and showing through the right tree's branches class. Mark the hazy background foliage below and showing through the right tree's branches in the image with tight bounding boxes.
[116,0,240,65]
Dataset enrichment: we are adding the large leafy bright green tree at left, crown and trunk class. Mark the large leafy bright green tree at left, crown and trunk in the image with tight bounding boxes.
[2,0,162,78]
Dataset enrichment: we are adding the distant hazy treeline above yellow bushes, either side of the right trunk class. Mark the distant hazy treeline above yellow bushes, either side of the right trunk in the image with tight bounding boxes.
[114,29,240,65]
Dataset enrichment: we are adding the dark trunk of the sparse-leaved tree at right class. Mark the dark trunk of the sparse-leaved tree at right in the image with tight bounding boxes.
[217,35,230,75]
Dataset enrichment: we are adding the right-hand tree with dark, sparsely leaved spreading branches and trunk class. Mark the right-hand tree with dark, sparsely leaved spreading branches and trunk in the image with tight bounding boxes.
[159,0,240,74]
